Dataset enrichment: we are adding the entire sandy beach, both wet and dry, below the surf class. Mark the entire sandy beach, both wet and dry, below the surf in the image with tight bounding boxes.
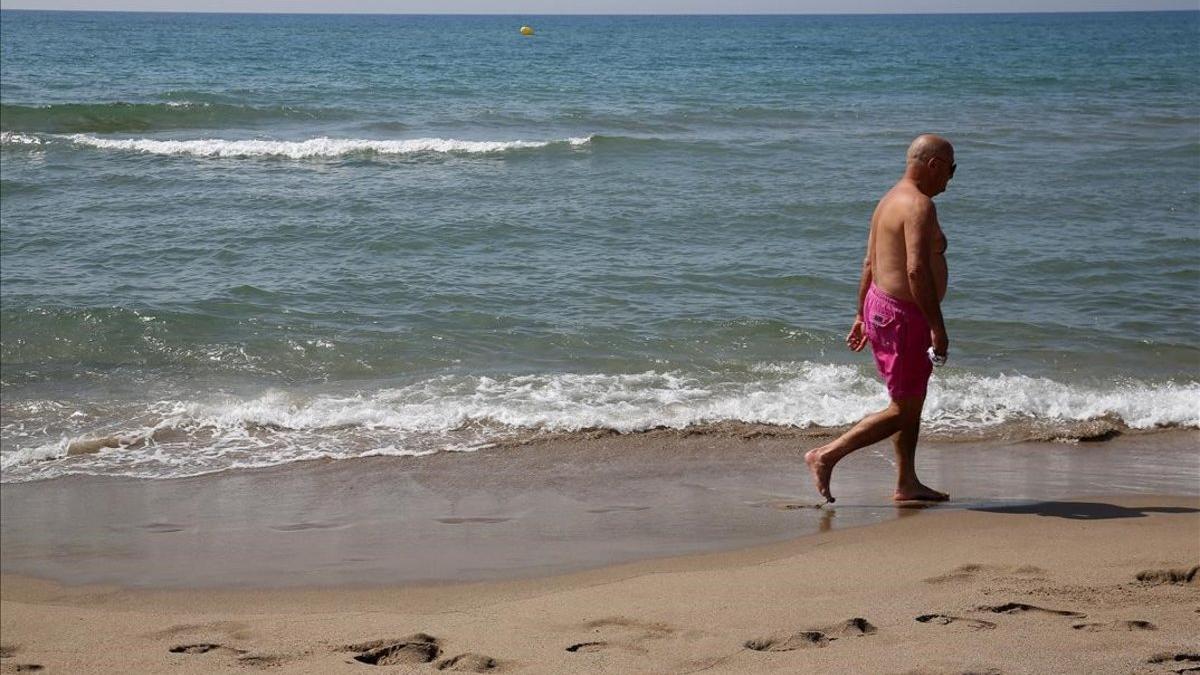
[0,431,1200,673]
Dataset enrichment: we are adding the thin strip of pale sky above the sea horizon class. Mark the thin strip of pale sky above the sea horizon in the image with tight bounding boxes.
[0,0,1200,14]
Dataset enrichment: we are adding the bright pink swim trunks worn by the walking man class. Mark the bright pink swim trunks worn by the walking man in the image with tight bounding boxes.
[863,283,934,400]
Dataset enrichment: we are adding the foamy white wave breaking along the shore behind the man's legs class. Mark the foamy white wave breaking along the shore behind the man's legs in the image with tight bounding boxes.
[0,362,1200,482]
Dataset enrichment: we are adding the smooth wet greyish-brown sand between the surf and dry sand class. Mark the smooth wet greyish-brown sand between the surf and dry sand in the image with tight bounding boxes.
[0,431,1200,587]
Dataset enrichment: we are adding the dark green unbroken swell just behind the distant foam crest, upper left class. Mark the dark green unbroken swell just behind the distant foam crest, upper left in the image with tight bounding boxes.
[0,101,341,133]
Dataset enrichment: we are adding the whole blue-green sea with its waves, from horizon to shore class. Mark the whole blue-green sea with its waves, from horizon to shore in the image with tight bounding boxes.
[0,11,1200,482]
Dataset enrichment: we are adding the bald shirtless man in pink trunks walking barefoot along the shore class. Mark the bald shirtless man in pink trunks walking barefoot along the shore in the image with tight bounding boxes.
[804,135,958,502]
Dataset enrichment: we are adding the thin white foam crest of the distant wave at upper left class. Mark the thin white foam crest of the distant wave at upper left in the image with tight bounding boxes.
[66,133,590,160]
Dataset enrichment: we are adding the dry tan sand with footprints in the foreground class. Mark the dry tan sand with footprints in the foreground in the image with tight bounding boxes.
[0,495,1200,674]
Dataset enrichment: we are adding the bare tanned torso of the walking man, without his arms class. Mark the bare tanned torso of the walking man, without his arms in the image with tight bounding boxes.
[869,181,949,301]
